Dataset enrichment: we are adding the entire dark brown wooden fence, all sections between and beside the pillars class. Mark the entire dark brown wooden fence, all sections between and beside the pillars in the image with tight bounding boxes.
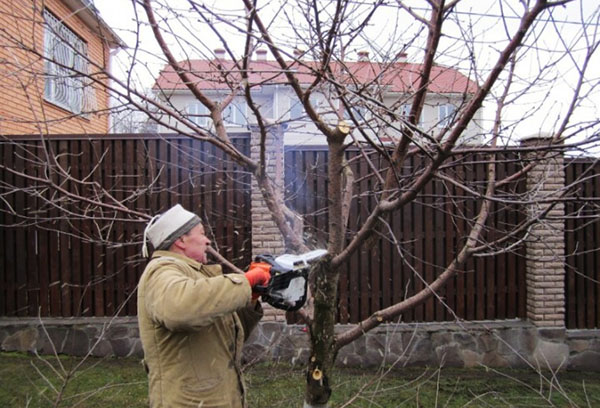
[0,135,600,328]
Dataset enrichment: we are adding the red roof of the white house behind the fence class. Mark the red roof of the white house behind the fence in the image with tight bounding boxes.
[154,59,478,94]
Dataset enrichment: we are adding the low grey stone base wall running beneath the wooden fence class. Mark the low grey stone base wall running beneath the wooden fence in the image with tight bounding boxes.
[0,317,600,370]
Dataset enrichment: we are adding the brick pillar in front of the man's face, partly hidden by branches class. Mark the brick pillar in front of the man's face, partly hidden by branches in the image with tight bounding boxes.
[250,127,285,321]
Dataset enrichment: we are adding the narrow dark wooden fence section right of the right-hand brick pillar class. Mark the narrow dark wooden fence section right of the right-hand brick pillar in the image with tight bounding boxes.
[565,159,600,329]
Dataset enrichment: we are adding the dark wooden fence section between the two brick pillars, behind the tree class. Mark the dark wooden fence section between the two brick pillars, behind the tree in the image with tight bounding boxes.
[285,148,526,323]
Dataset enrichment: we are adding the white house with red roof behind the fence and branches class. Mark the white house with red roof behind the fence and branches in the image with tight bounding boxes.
[153,50,483,145]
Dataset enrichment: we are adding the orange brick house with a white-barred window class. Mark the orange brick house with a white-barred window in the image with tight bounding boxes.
[0,0,123,135]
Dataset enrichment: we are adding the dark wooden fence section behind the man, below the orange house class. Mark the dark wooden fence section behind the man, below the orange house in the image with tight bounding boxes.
[0,135,251,316]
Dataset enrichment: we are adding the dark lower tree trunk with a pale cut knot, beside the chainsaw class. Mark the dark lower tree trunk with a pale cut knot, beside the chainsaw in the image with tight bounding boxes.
[304,258,339,408]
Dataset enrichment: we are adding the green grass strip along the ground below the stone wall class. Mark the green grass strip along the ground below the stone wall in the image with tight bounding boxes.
[0,353,600,408]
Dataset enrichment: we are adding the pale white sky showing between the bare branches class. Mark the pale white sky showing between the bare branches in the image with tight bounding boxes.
[94,0,600,145]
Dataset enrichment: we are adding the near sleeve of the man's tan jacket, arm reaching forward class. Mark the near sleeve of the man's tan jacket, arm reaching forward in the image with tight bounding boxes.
[144,264,251,331]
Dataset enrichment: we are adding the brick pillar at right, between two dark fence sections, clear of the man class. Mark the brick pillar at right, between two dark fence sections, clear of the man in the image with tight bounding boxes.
[521,136,565,329]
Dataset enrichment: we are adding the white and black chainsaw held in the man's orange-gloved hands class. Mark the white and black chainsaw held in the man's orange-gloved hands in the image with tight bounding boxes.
[254,249,327,312]
